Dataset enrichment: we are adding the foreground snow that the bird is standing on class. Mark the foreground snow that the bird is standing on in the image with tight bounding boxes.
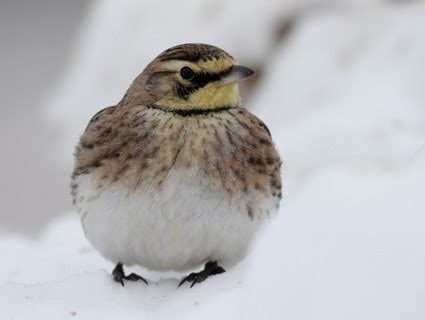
[0,157,425,319]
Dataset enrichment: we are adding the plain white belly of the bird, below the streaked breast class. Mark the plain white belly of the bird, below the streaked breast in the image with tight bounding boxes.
[78,171,275,271]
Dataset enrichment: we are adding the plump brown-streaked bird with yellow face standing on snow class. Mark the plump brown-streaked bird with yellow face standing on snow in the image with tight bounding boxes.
[71,43,282,287]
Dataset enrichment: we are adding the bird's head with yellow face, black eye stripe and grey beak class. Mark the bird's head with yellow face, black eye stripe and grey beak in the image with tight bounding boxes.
[122,44,254,110]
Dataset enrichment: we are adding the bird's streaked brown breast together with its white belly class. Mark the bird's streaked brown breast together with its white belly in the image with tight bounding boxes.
[73,113,278,270]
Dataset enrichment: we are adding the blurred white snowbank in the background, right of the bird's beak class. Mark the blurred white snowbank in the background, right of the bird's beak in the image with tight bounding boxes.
[250,4,425,188]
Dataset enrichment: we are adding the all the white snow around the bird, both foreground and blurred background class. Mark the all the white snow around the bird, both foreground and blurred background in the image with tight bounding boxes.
[0,0,425,320]
